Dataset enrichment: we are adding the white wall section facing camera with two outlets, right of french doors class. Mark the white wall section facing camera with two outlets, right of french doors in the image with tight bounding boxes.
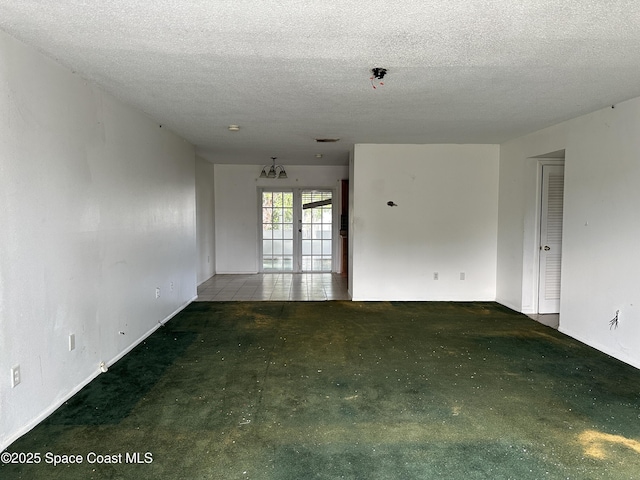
[350,144,499,301]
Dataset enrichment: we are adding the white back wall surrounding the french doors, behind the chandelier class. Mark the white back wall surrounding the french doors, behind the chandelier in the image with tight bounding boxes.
[214,164,348,273]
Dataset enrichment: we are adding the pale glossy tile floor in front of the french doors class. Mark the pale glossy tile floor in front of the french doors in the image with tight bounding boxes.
[197,273,349,302]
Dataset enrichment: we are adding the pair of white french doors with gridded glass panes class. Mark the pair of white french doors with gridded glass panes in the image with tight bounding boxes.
[260,189,334,272]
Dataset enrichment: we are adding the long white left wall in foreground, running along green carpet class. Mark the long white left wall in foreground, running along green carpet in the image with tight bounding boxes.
[0,33,196,450]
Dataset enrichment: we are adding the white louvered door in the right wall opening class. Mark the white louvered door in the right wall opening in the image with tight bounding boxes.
[538,165,564,313]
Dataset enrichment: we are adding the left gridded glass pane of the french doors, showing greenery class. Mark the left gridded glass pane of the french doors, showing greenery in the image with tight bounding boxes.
[262,192,293,271]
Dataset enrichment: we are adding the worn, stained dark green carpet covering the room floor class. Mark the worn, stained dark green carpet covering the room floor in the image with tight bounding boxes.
[0,302,640,480]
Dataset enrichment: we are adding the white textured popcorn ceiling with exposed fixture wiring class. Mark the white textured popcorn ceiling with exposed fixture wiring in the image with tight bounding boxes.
[0,0,640,164]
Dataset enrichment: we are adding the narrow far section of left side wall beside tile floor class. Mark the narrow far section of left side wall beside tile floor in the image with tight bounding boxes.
[196,156,216,285]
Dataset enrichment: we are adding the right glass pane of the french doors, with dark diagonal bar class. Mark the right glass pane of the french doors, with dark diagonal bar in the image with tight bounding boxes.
[300,190,333,272]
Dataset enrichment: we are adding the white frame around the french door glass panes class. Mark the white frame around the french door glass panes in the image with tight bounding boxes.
[257,186,340,274]
